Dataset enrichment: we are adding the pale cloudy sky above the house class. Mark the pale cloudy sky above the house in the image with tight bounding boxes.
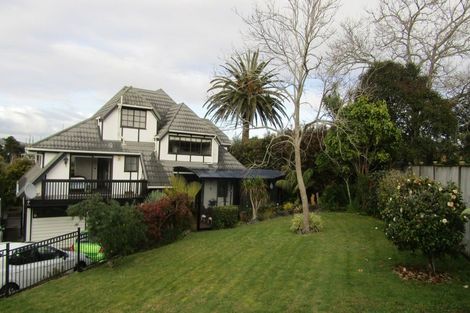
[0,0,371,141]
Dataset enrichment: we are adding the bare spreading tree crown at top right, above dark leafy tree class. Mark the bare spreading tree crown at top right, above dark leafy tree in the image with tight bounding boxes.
[332,0,470,84]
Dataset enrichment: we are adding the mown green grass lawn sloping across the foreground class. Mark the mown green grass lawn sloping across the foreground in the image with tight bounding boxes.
[0,213,470,312]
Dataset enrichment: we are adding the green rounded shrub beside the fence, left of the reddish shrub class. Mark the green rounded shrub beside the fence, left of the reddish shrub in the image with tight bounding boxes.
[67,195,146,259]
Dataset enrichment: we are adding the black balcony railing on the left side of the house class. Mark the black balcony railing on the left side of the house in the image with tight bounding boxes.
[40,179,147,200]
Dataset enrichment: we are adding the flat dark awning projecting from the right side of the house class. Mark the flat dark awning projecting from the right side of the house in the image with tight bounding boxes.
[188,168,284,179]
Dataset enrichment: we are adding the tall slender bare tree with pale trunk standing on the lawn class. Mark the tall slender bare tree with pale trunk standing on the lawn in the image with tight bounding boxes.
[244,0,338,232]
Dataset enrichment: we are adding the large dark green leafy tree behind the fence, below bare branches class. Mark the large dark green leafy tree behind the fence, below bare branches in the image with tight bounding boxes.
[358,61,457,164]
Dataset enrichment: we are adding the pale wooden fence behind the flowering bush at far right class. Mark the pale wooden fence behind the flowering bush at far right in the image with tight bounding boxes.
[412,166,470,256]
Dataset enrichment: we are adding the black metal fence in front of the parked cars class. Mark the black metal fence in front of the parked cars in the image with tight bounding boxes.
[0,228,97,297]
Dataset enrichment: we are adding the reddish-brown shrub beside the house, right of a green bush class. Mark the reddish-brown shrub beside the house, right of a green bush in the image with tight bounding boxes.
[138,192,192,243]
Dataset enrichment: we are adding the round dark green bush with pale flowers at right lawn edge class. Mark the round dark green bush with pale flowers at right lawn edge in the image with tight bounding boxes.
[382,176,466,273]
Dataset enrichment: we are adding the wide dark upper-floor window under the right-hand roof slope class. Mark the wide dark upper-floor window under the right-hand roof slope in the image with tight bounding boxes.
[168,135,212,156]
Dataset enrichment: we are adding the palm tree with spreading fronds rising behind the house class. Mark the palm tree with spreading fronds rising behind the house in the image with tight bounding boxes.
[204,51,287,142]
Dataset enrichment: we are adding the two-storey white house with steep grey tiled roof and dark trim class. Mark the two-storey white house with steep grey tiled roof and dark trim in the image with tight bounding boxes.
[17,87,281,241]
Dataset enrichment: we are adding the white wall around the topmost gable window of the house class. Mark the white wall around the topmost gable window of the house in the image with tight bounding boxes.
[103,108,157,142]
